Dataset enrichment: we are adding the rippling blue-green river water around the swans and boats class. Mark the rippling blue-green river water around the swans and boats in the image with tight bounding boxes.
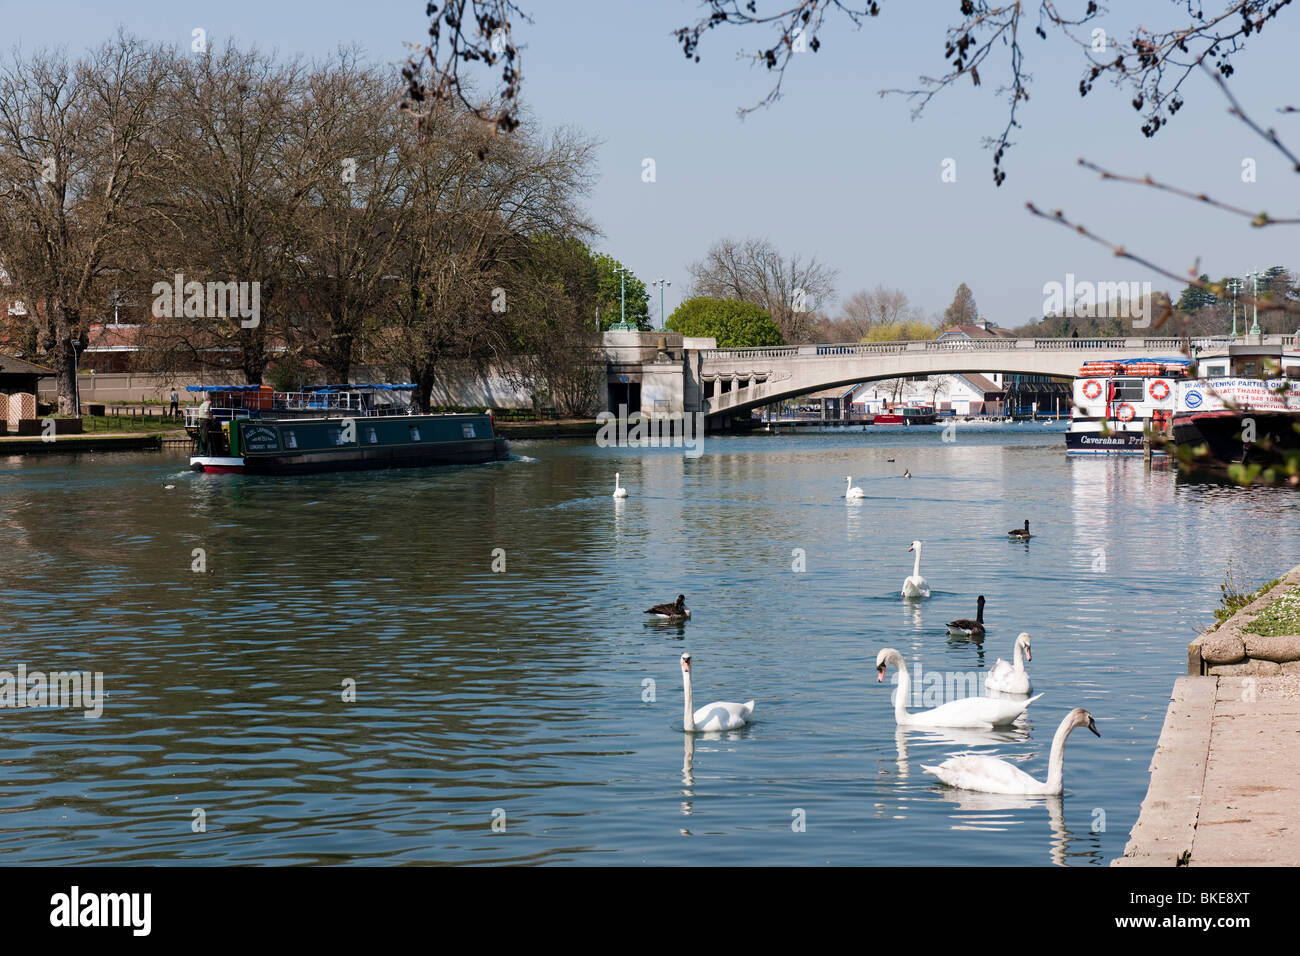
[0,424,1300,866]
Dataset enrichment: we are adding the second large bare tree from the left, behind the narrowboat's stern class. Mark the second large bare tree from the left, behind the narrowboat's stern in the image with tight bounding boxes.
[138,46,315,385]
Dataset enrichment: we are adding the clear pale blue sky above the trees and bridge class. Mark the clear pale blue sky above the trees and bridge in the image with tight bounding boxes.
[10,0,1300,328]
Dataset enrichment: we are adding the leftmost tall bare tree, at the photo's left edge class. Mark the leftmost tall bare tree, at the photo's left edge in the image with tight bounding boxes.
[0,33,165,415]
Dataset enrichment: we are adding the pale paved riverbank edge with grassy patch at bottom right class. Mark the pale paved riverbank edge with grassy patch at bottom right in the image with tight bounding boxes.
[1112,567,1300,866]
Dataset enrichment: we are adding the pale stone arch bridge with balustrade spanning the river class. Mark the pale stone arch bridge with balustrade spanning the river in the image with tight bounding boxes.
[686,334,1296,416]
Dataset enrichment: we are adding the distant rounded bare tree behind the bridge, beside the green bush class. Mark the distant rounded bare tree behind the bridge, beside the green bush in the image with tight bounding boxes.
[688,238,836,343]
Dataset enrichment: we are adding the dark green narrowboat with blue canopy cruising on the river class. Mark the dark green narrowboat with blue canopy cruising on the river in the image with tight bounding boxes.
[186,385,510,475]
